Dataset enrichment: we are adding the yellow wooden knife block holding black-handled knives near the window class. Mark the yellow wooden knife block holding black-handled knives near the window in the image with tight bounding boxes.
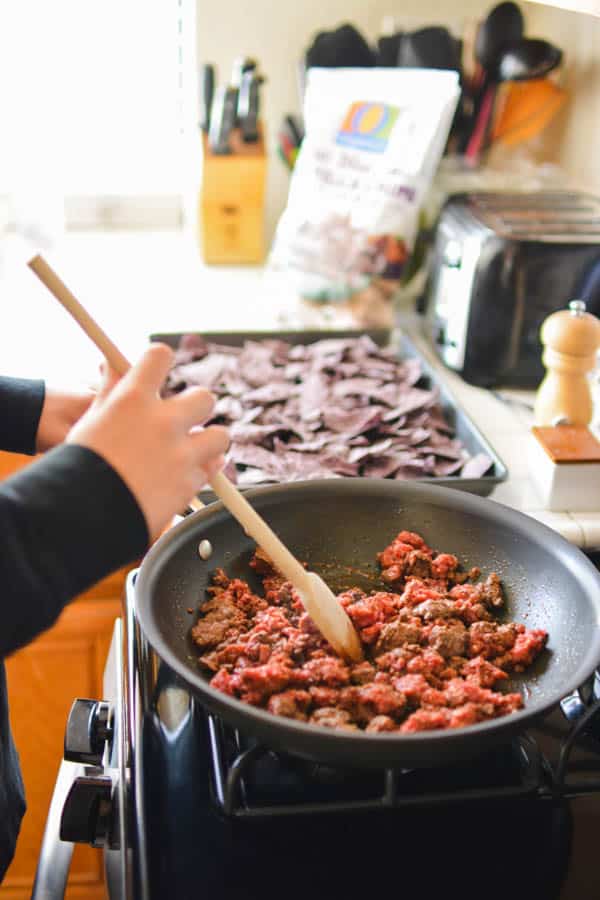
[198,127,267,265]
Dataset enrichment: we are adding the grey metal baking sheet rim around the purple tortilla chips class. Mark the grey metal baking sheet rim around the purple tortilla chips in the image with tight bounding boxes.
[150,329,508,503]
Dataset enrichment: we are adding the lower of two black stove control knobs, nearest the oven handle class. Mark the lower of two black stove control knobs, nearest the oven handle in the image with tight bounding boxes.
[60,775,113,847]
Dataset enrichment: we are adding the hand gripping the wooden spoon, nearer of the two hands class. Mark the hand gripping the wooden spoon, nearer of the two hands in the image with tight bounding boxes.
[67,344,229,540]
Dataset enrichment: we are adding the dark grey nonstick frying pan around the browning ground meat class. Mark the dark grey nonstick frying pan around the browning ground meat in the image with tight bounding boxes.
[136,479,600,768]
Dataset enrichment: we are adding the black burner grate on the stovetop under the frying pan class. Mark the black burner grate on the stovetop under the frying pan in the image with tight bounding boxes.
[207,696,600,819]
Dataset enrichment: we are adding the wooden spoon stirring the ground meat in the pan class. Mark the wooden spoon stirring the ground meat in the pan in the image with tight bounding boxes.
[28,255,362,661]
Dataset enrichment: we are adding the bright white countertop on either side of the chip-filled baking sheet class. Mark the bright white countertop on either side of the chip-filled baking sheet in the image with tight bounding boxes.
[0,225,600,549]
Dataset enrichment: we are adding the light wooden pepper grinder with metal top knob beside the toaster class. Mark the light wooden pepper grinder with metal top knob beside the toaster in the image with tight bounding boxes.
[534,300,600,425]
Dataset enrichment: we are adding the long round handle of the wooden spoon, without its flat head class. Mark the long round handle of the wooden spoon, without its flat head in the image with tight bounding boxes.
[28,256,307,589]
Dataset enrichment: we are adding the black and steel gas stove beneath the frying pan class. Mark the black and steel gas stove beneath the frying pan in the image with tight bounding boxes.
[33,572,600,900]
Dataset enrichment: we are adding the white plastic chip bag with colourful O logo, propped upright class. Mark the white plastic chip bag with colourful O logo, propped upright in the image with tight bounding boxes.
[269,68,460,318]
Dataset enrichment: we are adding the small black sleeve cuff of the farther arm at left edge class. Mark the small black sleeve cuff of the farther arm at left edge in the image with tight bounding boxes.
[0,376,45,455]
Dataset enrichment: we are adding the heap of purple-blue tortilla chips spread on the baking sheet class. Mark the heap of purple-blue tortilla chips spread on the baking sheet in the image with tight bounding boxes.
[164,335,492,486]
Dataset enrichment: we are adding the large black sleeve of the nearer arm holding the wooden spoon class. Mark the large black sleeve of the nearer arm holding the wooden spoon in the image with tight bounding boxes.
[0,444,148,657]
